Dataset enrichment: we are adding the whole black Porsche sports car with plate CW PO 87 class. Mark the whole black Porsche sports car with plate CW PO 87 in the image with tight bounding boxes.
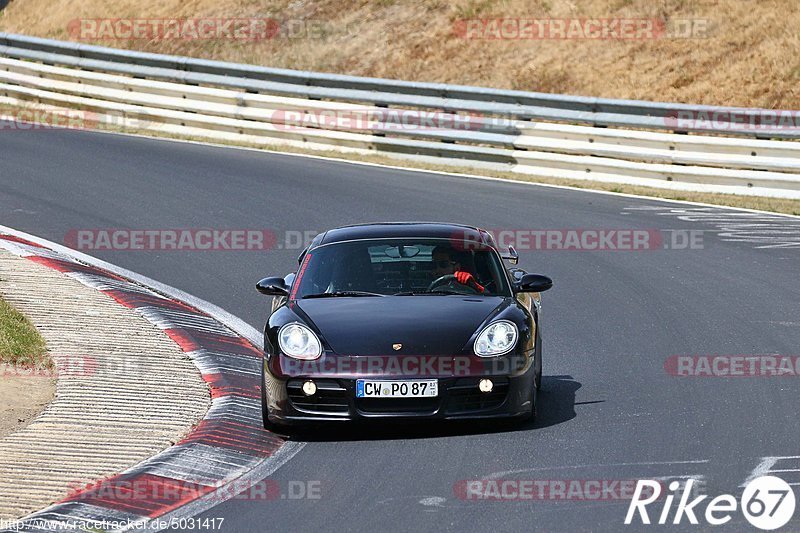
[257,223,553,427]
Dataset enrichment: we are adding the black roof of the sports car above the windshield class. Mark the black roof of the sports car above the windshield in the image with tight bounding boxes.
[311,222,495,248]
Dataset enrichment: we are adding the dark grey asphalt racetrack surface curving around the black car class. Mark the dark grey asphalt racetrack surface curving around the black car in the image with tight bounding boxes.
[0,131,800,532]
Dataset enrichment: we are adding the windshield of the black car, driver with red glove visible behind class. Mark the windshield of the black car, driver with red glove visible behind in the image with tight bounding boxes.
[292,239,511,299]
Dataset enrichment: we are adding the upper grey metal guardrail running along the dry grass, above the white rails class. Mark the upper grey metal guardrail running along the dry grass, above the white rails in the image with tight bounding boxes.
[0,32,800,138]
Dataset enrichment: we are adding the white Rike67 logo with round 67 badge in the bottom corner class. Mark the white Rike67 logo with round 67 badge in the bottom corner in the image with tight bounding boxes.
[625,476,795,531]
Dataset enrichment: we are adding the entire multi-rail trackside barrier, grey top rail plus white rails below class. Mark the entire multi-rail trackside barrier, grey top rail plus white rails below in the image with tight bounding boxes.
[0,33,800,198]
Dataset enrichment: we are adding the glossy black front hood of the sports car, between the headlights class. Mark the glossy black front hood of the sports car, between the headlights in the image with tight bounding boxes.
[297,296,512,355]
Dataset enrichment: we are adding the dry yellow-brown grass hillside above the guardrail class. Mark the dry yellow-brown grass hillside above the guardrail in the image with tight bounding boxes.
[0,0,800,109]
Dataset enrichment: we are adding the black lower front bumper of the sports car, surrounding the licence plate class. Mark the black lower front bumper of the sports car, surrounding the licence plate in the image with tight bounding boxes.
[262,353,535,424]
